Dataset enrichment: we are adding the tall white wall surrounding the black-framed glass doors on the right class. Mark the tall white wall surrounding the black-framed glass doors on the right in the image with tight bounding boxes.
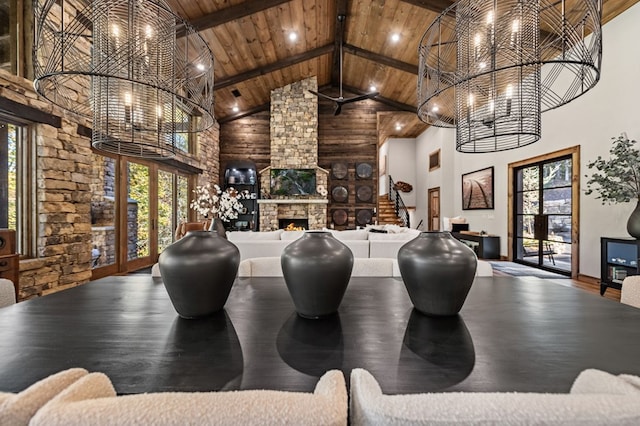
[408,3,640,277]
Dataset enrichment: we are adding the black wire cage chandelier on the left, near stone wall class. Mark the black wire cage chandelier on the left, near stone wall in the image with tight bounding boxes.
[33,0,214,159]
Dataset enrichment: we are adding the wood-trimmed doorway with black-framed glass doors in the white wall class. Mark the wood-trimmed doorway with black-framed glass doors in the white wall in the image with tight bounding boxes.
[509,147,580,277]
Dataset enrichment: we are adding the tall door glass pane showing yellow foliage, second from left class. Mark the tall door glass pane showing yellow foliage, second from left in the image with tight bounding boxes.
[127,163,150,260]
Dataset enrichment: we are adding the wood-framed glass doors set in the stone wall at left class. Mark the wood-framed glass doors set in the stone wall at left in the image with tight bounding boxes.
[91,154,190,279]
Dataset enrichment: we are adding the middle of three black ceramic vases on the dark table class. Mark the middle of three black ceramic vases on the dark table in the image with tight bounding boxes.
[280,231,353,318]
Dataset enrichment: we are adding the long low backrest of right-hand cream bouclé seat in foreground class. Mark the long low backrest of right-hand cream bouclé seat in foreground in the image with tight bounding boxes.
[350,369,640,426]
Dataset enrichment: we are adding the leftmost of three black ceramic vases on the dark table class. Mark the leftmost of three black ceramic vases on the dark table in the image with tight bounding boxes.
[158,231,240,318]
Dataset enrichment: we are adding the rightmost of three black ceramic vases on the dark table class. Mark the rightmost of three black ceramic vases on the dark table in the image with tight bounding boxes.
[398,231,478,316]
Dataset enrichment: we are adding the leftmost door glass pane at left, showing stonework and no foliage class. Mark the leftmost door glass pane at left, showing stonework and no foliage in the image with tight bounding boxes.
[91,154,117,268]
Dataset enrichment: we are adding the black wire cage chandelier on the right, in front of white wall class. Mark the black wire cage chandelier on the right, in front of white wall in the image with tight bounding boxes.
[418,0,602,152]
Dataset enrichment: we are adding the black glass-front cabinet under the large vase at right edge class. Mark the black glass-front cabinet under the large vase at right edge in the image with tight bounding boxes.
[600,237,640,295]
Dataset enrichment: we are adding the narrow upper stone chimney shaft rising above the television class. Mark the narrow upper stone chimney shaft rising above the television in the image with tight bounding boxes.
[270,76,318,168]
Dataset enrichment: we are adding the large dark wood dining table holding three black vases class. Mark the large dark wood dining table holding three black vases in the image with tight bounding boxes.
[0,274,640,394]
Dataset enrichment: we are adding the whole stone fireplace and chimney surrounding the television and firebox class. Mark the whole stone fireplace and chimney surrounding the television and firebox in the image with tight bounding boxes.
[258,77,329,231]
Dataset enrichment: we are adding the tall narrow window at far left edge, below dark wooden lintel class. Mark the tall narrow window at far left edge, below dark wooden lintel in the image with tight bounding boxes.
[0,118,35,255]
